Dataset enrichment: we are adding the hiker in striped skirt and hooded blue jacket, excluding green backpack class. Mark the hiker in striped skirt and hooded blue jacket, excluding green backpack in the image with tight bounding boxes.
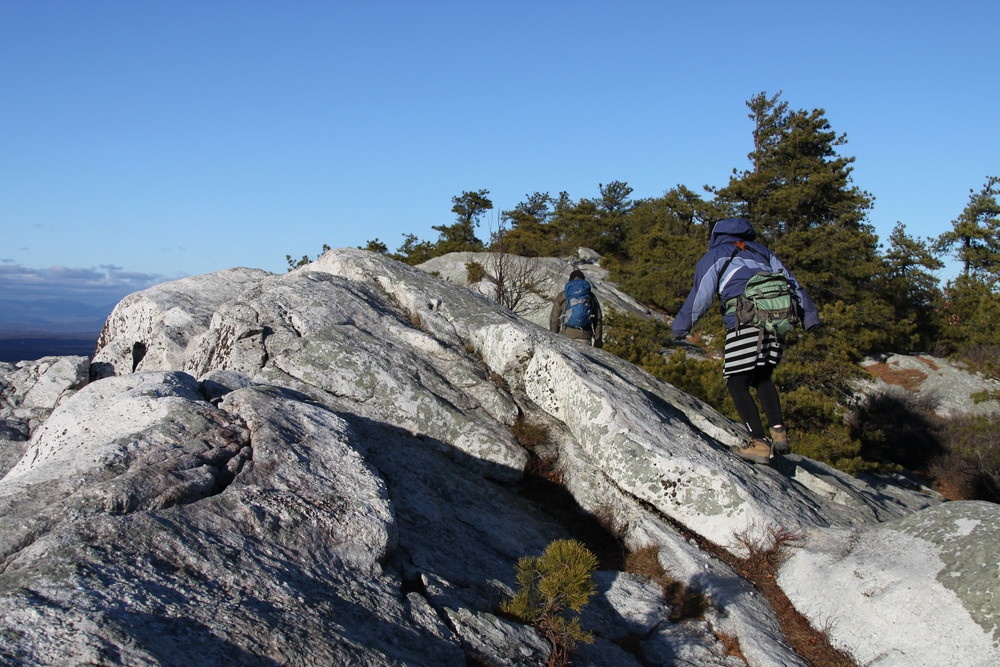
[673,218,819,463]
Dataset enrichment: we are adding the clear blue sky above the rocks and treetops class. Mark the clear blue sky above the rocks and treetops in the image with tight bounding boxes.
[0,0,1000,306]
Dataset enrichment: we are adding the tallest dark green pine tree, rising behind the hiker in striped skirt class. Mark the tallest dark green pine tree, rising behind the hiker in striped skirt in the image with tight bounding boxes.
[715,93,912,354]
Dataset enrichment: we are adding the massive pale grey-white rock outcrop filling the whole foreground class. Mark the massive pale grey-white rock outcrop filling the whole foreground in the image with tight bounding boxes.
[0,250,1000,665]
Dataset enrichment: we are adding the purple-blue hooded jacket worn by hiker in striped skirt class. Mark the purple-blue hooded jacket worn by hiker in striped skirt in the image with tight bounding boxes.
[673,218,819,338]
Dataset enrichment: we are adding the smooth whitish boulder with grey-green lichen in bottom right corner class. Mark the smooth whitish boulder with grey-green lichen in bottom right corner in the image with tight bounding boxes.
[778,501,1000,667]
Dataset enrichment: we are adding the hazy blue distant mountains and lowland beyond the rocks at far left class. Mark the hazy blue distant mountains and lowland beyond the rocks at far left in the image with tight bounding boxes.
[0,299,115,363]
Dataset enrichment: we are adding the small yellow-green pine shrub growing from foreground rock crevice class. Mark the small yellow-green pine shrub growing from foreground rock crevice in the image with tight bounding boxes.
[501,540,597,667]
